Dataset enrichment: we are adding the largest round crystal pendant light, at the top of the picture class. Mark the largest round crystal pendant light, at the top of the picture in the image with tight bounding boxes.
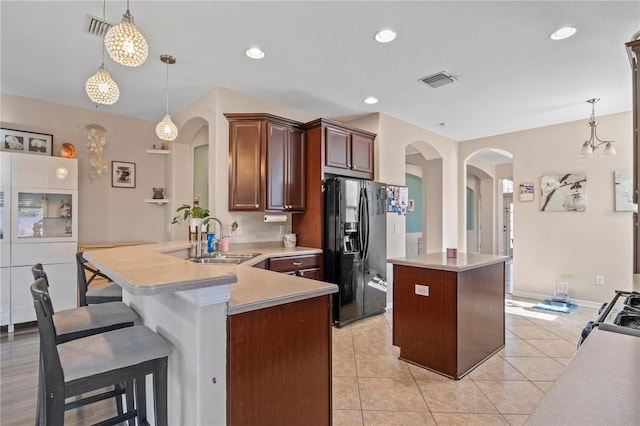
[104,0,149,67]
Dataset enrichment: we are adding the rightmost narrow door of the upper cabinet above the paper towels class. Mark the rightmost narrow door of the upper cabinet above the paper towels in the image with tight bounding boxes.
[285,128,305,211]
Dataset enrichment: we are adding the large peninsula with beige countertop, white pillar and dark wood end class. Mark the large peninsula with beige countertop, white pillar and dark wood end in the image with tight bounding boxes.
[85,241,337,425]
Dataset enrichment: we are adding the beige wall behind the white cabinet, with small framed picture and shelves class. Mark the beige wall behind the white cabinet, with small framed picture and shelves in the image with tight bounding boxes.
[0,94,172,243]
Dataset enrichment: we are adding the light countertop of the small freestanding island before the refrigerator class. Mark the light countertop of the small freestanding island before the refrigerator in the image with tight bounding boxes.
[387,252,509,272]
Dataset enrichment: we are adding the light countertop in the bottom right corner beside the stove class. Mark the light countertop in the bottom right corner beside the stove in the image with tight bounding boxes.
[526,327,640,426]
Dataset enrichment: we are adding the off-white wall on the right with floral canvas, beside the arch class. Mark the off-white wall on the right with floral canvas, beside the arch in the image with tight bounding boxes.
[459,113,633,302]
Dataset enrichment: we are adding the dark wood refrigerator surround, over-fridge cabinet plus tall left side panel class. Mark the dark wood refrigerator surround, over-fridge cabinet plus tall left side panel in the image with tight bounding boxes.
[292,119,376,248]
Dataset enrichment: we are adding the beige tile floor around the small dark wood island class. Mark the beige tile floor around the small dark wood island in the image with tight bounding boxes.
[333,298,597,426]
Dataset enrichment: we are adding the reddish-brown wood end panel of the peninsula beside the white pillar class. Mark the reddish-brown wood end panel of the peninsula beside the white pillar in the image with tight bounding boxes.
[227,296,331,426]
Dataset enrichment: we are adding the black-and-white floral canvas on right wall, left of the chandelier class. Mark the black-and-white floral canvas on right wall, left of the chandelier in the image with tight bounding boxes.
[540,173,587,212]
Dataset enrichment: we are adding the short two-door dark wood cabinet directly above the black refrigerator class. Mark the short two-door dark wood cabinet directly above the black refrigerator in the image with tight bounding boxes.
[306,118,376,179]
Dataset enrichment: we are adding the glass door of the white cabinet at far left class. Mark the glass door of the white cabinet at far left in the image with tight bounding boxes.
[13,190,77,242]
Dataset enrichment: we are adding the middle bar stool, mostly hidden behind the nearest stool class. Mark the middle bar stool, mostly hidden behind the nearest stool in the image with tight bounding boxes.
[31,263,139,426]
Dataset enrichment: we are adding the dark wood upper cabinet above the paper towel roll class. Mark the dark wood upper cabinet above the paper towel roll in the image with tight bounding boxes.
[225,114,305,212]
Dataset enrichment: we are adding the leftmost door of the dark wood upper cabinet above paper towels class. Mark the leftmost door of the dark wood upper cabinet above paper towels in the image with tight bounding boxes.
[229,120,264,211]
